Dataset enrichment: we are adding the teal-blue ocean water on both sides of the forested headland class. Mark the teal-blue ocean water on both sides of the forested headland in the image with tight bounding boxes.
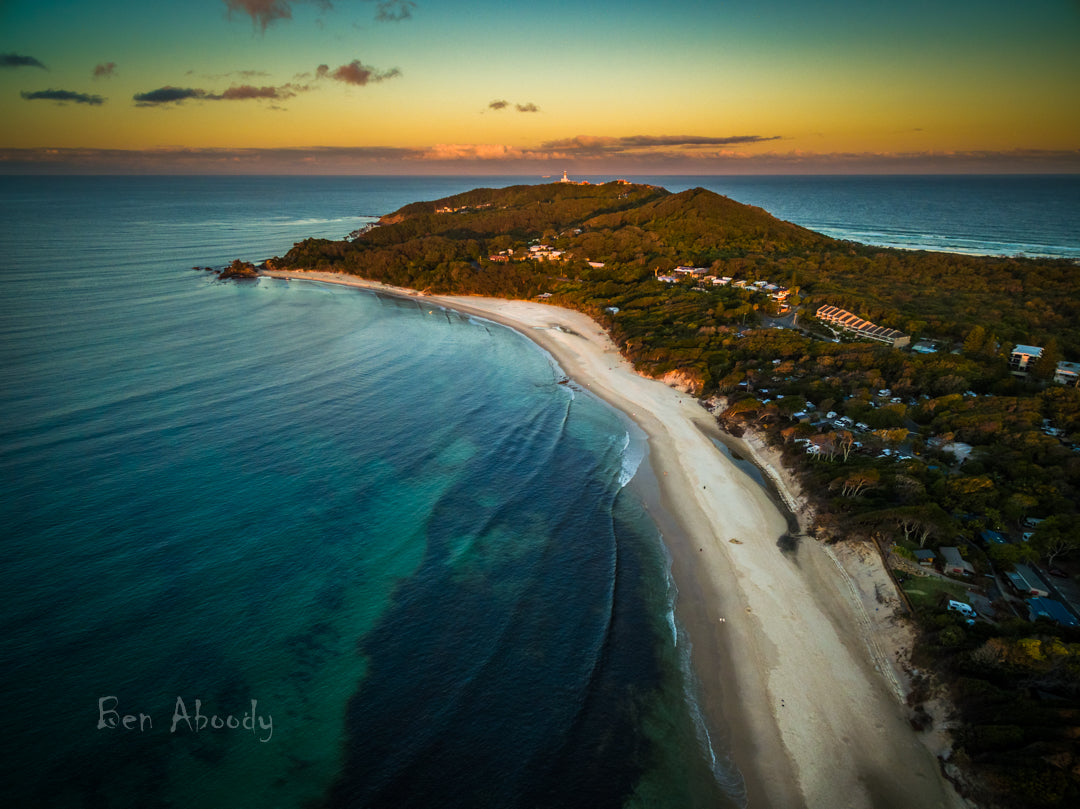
[0,177,1080,808]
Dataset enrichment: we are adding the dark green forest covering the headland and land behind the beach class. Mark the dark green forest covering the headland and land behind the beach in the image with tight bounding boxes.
[268,183,1080,808]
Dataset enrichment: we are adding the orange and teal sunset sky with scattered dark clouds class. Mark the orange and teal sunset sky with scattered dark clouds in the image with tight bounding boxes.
[0,0,1080,171]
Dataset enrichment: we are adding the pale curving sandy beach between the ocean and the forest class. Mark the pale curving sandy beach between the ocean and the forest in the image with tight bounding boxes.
[266,272,966,809]
